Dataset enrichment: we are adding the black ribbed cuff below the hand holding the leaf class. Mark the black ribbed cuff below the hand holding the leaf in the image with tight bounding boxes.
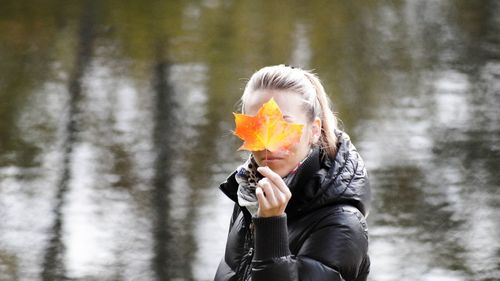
[252,215,290,260]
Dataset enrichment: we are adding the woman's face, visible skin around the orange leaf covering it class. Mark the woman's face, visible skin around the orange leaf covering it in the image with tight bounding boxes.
[243,90,321,177]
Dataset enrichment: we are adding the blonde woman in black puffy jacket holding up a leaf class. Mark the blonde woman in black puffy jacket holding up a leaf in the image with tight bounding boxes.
[215,65,370,281]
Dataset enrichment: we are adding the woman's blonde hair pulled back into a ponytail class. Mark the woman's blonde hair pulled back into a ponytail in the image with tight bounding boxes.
[241,64,338,158]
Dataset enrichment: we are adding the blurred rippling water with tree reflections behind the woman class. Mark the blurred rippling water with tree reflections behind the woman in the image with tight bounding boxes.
[0,0,500,281]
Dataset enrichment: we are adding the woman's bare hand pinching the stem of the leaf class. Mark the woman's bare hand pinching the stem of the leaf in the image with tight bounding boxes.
[255,167,292,217]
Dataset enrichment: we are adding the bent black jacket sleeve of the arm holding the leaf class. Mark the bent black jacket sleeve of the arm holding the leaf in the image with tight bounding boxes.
[252,207,369,281]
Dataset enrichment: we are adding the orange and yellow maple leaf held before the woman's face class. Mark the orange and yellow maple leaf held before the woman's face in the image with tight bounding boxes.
[233,98,304,152]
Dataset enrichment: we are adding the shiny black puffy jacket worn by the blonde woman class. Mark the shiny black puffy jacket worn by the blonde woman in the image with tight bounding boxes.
[215,131,370,281]
